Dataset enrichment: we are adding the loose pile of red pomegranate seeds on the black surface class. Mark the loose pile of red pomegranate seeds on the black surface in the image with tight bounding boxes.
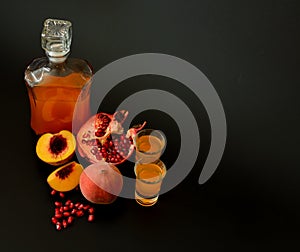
[51,190,95,230]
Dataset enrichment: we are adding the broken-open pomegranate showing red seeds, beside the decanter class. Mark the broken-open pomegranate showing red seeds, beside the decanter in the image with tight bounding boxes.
[77,110,146,165]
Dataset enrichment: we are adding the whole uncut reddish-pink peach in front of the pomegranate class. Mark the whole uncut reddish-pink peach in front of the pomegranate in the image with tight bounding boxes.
[79,162,123,204]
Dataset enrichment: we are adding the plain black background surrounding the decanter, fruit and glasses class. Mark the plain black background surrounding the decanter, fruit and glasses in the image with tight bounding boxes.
[0,0,300,251]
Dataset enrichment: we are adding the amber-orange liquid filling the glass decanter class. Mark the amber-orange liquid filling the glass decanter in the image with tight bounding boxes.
[28,70,91,134]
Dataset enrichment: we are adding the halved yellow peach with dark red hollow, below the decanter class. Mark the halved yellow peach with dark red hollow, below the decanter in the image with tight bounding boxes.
[36,130,76,165]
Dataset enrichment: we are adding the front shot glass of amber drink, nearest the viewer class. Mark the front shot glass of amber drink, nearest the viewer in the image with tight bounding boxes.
[134,160,167,206]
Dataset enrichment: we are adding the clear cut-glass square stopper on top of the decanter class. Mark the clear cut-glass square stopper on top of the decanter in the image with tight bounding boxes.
[41,18,72,57]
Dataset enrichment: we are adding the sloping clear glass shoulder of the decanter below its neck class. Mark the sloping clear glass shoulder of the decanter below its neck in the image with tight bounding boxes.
[24,57,93,87]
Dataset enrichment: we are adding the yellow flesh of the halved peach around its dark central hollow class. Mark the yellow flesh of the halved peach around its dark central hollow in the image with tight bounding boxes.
[36,130,76,166]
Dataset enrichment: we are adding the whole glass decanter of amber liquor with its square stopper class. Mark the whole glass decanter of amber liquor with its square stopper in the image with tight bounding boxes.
[25,19,92,134]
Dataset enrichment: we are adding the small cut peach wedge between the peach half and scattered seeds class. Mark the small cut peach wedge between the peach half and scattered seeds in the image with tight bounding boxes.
[47,161,83,192]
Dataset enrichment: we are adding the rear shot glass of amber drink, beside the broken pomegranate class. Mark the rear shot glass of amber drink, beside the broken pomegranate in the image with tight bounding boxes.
[133,129,166,163]
